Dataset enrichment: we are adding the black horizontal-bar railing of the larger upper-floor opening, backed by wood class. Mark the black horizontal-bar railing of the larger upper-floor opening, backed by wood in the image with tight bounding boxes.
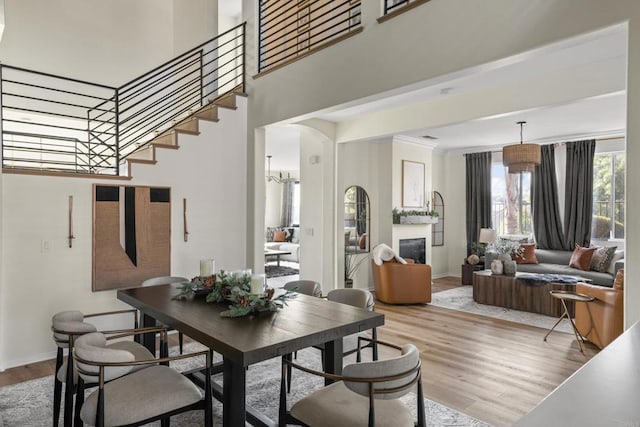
[258,0,361,72]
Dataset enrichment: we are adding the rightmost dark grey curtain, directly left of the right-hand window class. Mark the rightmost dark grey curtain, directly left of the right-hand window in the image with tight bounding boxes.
[564,139,596,249]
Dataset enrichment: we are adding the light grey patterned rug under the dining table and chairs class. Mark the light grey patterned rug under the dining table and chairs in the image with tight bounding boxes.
[0,343,488,427]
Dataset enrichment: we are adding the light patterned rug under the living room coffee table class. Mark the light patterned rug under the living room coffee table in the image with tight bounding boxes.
[431,286,573,333]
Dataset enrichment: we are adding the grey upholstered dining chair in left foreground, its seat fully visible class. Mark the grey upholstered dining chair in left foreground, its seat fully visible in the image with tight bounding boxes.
[74,330,213,426]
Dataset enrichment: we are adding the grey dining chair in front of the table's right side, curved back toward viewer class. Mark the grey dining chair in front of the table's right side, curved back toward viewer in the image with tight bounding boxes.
[278,338,426,427]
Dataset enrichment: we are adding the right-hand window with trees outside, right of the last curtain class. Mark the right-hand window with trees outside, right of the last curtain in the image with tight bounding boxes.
[591,152,625,240]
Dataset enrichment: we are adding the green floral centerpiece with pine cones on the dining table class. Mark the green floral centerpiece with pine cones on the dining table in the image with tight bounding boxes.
[174,270,295,317]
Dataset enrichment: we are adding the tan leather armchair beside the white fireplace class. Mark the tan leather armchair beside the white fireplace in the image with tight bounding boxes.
[371,260,431,304]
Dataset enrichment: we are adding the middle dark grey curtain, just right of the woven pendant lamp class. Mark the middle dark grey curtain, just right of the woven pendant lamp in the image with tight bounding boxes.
[531,144,573,250]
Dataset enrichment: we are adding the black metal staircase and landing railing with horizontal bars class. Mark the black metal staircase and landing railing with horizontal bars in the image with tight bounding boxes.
[0,24,245,175]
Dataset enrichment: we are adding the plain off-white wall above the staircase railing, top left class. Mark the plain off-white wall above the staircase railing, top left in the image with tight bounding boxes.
[0,0,218,86]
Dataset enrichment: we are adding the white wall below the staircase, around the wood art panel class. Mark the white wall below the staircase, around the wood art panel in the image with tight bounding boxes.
[0,98,247,369]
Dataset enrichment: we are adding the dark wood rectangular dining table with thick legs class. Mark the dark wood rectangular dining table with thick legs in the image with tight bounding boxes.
[117,284,384,426]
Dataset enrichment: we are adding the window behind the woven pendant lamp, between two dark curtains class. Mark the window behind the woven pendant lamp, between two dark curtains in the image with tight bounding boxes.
[491,162,532,236]
